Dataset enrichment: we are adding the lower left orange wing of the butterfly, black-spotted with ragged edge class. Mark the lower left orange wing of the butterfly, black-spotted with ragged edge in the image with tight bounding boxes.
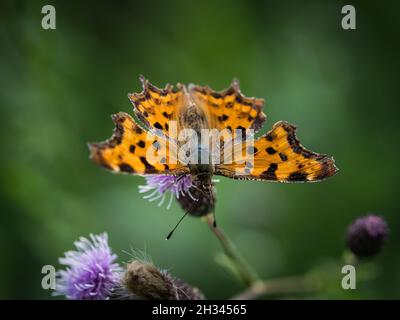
[89,112,185,174]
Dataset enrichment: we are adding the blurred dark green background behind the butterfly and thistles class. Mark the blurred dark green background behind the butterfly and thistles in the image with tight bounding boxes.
[0,0,400,299]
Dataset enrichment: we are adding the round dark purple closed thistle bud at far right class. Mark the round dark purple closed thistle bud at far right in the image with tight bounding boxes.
[346,215,389,257]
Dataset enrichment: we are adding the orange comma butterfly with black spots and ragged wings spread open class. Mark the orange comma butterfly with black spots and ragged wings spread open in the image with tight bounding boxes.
[89,77,337,215]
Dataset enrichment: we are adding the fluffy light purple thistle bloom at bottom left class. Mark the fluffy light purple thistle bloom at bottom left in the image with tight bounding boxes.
[54,233,122,300]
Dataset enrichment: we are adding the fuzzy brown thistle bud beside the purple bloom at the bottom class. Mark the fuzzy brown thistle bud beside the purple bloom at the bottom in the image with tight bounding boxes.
[122,260,204,300]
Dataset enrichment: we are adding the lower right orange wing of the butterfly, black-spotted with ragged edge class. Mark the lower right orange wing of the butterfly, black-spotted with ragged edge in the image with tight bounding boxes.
[215,121,337,182]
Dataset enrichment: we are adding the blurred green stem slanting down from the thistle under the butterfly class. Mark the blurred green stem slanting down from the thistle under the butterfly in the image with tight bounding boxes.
[205,213,259,288]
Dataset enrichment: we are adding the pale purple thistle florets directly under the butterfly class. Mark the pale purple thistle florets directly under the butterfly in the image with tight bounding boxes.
[139,174,197,209]
